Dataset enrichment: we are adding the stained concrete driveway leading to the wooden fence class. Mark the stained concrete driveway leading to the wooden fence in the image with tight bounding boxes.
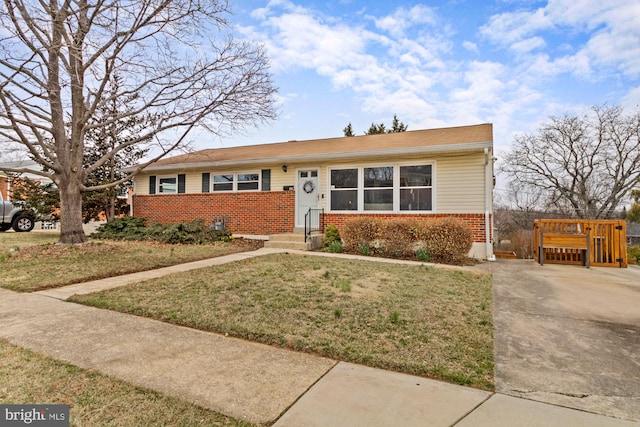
[493,260,640,421]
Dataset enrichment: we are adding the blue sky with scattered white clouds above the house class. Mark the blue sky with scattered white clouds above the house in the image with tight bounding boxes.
[210,0,640,156]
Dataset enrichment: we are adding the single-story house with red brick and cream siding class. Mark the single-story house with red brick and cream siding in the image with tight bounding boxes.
[132,124,493,258]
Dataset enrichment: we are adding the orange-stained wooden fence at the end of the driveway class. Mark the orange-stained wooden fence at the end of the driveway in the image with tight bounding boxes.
[533,219,627,268]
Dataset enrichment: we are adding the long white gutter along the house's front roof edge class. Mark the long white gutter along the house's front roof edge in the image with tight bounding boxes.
[129,141,493,172]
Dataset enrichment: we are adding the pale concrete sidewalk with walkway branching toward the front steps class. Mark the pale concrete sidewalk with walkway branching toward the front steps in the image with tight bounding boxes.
[0,250,640,427]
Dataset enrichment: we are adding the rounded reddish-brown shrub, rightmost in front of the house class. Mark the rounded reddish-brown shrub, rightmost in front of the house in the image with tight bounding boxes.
[415,218,473,264]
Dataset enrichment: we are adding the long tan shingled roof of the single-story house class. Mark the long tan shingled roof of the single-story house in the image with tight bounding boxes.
[146,123,493,171]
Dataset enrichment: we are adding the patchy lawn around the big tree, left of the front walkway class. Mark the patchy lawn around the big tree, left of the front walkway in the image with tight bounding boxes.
[0,239,263,292]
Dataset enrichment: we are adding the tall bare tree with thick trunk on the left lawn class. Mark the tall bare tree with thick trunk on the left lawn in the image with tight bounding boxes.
[0,0,276,243]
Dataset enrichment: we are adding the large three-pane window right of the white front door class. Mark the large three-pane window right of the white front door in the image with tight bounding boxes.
[329,164,433,212]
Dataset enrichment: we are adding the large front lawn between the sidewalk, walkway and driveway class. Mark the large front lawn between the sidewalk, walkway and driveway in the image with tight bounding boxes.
[73,254,493,390]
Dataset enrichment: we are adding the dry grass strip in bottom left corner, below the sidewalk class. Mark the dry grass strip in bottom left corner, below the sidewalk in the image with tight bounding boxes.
[0,340,251,427]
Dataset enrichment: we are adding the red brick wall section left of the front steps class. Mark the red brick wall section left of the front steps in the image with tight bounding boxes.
[133,191,295,235]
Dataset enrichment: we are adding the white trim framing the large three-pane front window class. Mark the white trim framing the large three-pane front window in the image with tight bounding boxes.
[326,160,436,215]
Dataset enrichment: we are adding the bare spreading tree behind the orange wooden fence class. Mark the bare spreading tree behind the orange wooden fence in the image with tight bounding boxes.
[501,106,640,218]
